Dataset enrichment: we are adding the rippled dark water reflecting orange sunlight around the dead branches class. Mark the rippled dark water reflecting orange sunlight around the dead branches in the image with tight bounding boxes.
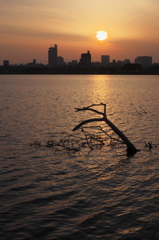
[0,75,159,240]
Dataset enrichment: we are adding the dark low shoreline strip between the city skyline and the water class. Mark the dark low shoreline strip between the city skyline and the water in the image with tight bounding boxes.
[0,64,159,75]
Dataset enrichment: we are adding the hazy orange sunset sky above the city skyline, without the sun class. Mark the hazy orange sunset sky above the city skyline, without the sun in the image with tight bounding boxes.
[0,0,159,65]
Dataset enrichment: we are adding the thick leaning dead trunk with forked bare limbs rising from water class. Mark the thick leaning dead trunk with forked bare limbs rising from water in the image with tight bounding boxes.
[73,103,138,156]
